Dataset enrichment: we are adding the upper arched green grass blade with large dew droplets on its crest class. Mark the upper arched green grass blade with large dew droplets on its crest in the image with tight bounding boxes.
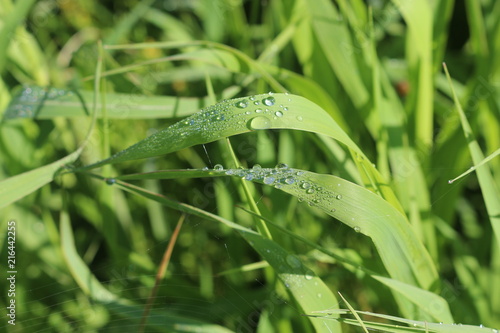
[78,93,402,212]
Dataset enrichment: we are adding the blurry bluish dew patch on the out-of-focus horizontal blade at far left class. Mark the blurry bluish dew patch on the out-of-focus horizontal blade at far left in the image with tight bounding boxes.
[4,85,73,119]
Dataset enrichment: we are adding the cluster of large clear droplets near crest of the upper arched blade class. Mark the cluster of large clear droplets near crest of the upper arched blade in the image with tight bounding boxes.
[234,92,292,130]
